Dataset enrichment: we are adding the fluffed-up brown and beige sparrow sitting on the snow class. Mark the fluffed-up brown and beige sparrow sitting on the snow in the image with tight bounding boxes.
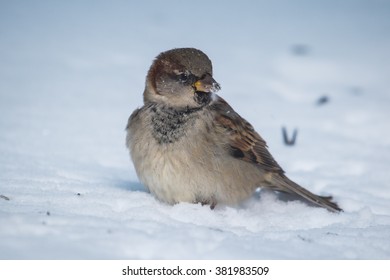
[126,48,341,211]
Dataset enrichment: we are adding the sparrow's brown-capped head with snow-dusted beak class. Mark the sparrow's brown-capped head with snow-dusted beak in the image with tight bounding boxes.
[144,48,220,108]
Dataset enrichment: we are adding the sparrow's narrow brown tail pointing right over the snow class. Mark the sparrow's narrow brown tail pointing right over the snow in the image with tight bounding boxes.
[271,174,343,212]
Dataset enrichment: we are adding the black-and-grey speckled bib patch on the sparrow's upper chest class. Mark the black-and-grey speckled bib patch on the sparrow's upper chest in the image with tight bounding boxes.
[150,107,197,145]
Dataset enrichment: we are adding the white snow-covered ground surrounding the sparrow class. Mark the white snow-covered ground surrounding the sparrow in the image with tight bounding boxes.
[0,0,390,259]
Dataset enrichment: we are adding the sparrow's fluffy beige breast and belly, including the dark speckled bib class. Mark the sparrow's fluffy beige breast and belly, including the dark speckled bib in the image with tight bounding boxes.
[128,104,255,204]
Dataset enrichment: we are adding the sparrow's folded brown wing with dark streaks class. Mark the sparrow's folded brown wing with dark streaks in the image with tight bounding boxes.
[210,96,284,173]
